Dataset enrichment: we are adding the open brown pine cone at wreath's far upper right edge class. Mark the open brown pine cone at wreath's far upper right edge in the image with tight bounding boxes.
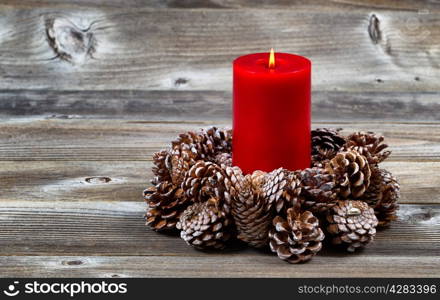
[344,132,391,165]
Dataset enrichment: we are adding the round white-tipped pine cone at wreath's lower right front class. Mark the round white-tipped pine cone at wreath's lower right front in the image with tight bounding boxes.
[326,200,378,252]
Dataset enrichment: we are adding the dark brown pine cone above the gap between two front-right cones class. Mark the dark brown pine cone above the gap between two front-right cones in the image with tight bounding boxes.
[297,168,339,215]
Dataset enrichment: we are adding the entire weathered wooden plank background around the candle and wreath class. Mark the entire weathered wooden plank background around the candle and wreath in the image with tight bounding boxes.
[0,0,440,277]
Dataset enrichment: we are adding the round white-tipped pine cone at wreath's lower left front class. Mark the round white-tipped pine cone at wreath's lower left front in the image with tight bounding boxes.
[177,198,232,249]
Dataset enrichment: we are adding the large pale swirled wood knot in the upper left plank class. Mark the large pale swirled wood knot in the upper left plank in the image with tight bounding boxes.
[46,18,97,64]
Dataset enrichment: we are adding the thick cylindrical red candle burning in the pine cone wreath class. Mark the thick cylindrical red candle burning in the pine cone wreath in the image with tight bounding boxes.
[232,53,311,174]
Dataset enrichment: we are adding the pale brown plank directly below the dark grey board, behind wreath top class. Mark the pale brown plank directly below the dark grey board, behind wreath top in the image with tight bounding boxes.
[0,120,440,161]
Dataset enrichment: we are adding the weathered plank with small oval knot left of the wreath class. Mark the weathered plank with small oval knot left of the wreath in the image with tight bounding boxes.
[0,159,440,204]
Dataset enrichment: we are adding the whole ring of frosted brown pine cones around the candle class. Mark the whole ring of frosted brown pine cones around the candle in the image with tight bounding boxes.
[144,127,400,263]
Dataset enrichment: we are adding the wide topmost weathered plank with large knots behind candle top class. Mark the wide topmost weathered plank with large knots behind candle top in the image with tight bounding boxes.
[0,6,440,92]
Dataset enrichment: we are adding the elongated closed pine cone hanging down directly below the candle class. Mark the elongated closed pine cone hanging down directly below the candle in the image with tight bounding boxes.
[232,171,274,248]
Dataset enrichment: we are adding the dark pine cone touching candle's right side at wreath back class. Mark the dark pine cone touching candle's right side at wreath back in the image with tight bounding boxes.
[311,128,345,161]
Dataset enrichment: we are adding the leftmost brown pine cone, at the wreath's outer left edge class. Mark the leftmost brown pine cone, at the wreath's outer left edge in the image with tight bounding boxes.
[144,181,189,231]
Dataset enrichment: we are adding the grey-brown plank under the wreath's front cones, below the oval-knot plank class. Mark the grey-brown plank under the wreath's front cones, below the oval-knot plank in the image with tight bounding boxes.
[0,201,440,261]
